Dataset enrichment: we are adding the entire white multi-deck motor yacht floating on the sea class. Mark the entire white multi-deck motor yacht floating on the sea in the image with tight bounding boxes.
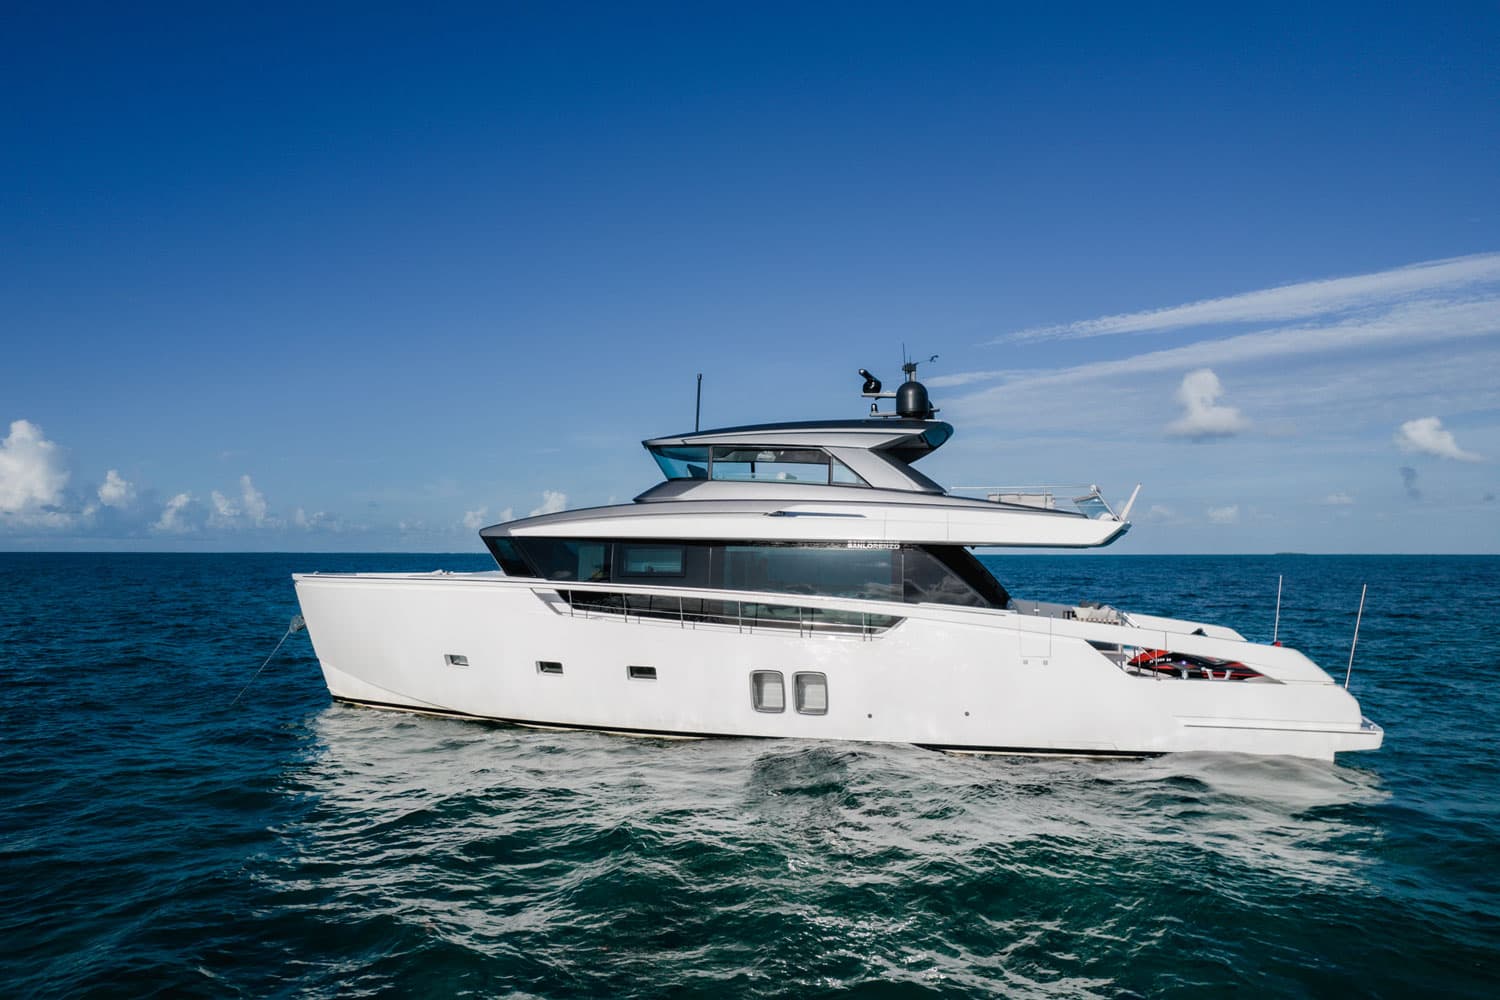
[294,364,1383,760]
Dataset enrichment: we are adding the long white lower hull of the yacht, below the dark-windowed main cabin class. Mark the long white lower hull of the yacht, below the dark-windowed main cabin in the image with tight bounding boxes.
[296,574,1382,760]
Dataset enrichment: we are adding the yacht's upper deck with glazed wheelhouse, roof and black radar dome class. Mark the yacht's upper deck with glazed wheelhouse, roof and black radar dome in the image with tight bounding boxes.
[482,363,1130,549]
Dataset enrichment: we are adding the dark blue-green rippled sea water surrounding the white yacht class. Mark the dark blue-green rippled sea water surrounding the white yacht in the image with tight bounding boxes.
[0,555,1500,997]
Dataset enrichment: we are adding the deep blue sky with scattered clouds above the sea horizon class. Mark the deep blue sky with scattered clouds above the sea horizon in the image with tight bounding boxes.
[0,3,1500,552]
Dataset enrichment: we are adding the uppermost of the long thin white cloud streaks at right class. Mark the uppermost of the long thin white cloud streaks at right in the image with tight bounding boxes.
[992,253,1500,343]
